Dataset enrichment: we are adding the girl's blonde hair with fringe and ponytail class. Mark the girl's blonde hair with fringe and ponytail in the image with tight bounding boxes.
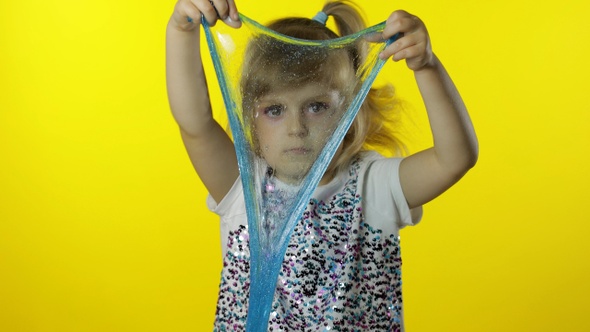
[241,0,406,172]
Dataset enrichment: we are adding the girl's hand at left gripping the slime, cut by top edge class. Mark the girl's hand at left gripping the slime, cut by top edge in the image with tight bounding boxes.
[171,0,242,31]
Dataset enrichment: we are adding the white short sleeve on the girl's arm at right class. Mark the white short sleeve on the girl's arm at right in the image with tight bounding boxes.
[363,158,422,230]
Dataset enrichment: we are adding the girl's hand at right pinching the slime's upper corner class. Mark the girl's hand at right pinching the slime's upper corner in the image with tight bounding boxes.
[379,10,434,71]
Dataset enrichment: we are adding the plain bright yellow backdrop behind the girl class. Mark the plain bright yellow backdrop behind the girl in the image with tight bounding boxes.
[0,0,590,332]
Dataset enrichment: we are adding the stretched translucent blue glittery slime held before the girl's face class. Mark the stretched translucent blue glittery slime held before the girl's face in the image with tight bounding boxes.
[203,15,395,332]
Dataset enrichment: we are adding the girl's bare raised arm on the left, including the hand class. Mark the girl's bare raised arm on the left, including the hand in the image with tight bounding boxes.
[166,0,241,202]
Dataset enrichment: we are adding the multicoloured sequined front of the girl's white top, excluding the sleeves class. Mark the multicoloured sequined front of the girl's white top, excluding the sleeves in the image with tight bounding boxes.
[215,161,403,332]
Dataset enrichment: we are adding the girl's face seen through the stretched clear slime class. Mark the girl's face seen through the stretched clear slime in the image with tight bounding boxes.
[254,83,344,183]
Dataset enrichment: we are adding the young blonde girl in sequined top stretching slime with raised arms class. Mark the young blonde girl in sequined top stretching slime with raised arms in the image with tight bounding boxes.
[167,0,478,331]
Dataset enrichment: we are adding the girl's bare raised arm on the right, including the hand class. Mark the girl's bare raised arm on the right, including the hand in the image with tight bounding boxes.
[381,11,479,207]
